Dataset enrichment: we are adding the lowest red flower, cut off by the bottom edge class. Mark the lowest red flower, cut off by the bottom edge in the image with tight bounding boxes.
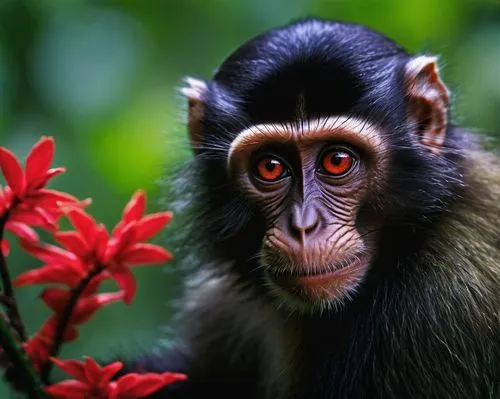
[45,357,186,399]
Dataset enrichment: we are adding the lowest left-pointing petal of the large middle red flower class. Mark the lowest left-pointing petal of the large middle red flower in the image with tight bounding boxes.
[12,264,83,287]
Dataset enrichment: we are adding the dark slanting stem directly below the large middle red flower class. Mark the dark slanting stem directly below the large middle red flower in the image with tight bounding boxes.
[40,266,104,384]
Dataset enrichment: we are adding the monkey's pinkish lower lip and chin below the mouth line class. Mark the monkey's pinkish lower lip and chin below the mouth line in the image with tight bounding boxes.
[268,256,370,311]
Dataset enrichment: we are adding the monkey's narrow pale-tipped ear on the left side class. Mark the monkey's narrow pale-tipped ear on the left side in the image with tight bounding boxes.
[180,77,207,150]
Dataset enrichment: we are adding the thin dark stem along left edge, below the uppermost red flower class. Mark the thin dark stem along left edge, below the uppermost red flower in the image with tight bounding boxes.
[0,212,28,342]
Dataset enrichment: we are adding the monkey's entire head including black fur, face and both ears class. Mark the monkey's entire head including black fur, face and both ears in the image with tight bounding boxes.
[183,20,458,309]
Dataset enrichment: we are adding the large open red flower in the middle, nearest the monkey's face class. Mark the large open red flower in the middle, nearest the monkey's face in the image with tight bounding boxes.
[14,190,172,304]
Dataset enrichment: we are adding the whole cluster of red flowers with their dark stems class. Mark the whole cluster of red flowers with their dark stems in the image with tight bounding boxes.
[0,137,186,399]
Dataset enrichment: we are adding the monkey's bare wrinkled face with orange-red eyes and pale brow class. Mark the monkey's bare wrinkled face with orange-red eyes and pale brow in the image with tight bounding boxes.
[229,117,386,307]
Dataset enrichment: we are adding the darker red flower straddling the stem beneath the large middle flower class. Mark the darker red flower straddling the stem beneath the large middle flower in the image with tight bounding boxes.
[24,276,123,370]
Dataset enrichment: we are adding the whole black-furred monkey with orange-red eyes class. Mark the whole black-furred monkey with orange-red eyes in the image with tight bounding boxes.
[118,18,500,399]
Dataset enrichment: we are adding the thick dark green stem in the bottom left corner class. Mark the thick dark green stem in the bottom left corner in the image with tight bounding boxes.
[0,317,46,399]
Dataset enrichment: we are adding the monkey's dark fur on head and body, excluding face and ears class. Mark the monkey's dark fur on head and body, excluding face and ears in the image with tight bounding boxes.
[119,20,500,399]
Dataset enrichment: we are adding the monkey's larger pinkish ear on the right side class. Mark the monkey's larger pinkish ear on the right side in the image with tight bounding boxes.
[405,55,450,154]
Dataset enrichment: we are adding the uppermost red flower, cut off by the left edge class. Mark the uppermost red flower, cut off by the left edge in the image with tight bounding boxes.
[0,137,83,247]
